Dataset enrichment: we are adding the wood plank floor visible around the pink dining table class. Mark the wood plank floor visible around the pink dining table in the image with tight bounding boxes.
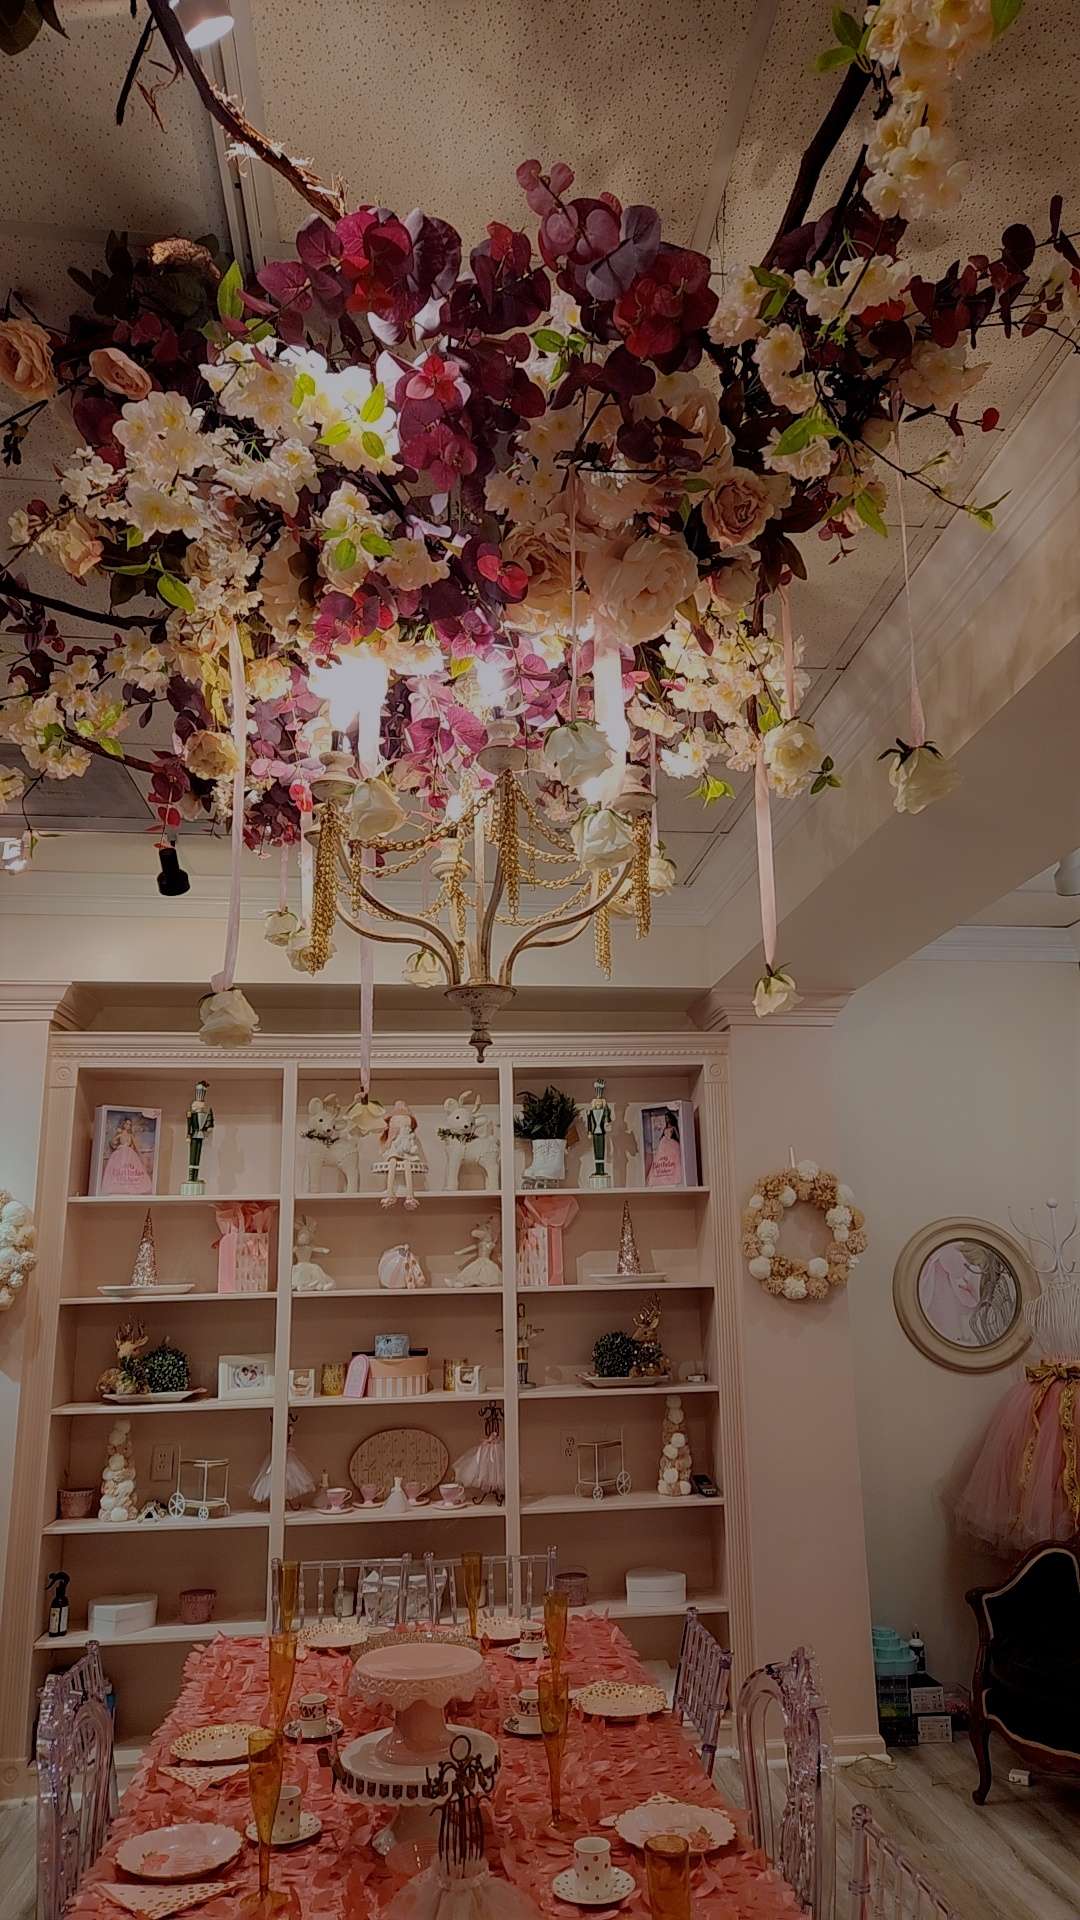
[0,1741,1080,1920]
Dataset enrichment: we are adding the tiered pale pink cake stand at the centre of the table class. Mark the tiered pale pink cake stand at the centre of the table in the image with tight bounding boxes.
[332,1634,498,1870]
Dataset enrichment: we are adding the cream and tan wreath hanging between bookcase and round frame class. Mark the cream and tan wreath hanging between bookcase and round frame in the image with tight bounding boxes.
[742,1160,867,1300]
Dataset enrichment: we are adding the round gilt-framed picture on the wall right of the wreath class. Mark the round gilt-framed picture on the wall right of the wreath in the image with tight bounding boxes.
[892,1215,1042,1373]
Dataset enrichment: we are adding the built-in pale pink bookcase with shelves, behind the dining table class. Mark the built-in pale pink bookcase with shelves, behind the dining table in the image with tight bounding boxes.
[0,1031,749,1755]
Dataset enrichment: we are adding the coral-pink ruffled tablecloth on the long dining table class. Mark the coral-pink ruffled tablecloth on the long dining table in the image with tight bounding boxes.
[69,1615,801,1920]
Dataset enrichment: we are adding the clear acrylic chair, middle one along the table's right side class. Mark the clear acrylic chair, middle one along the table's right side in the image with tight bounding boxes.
[736,1647,836,1920]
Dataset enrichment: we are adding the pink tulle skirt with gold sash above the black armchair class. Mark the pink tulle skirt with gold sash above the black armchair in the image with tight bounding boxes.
[955,1380,1080,1551]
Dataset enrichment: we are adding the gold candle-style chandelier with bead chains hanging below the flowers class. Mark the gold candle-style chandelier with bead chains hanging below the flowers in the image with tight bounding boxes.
[304,720,667,1060]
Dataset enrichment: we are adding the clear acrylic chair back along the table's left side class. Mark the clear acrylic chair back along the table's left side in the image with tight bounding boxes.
[35,1640,117,1920]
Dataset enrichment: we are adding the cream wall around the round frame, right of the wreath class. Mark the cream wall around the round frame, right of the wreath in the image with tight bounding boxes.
[834,960,1080,1682]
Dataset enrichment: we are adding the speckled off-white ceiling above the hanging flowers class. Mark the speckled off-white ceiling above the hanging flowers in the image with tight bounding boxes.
[0,0,1080,906]
